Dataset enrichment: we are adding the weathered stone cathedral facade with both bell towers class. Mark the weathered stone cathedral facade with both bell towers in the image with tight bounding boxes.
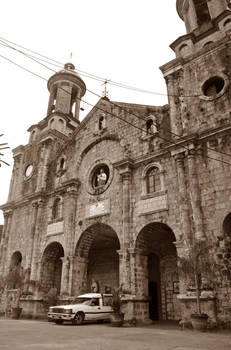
[0,0,231,322]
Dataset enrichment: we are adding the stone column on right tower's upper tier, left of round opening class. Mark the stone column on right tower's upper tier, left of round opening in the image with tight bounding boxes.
[165,75,182,138]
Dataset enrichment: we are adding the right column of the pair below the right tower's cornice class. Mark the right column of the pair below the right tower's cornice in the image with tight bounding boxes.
[188,149,204,239]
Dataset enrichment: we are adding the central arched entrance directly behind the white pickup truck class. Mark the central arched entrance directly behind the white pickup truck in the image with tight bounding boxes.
[73,223,120,293]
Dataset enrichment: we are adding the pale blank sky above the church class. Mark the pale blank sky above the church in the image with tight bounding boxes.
[0,0,185,224]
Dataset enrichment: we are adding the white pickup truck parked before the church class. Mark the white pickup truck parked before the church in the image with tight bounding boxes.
[47,293,113,325]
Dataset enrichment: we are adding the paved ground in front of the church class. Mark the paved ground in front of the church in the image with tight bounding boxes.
[0,319,231,350]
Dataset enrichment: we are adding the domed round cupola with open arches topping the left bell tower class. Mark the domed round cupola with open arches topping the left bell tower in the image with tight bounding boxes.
[47,62,86,120]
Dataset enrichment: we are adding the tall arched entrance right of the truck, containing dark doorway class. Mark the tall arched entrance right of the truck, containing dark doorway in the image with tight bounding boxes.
[136,223,180,320]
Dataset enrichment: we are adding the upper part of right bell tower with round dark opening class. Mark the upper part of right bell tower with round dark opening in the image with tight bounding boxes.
[160,0,231,138]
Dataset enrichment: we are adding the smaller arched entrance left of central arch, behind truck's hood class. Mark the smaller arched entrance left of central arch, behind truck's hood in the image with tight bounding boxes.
[40,242,64,294]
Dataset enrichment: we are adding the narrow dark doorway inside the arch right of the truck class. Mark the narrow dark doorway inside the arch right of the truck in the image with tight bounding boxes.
[148,253,161,320]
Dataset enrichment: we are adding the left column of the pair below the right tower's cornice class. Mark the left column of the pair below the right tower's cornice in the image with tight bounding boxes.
[175,153,191,243]
